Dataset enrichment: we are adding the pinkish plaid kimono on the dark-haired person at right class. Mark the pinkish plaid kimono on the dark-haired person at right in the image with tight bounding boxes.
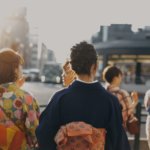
[107,85,135,128]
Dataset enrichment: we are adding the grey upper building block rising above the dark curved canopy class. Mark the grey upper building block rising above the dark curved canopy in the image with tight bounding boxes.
[92,24,150,44]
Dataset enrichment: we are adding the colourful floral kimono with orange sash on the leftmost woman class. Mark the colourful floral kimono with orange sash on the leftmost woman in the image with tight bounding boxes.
[0,83,39,150]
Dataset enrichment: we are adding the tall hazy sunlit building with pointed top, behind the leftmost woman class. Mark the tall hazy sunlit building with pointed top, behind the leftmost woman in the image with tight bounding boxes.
[0,7,30,67]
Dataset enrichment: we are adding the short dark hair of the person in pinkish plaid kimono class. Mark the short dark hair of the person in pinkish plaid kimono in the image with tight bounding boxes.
[102,66,122,83]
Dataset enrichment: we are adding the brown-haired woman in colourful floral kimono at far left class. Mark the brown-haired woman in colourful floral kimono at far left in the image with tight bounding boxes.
[0,48,39,150]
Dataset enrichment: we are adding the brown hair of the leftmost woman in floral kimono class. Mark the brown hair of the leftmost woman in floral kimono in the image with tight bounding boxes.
[0,48,23,84]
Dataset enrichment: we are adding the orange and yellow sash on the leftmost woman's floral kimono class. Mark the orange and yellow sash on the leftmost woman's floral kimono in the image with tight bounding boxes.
[0,125,26,150]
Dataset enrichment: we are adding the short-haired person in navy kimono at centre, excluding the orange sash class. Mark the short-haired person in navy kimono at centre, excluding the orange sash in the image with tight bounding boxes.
[36,42,130,150]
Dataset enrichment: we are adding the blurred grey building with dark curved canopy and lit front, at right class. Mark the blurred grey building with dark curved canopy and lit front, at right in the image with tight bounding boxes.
[91,24,150,83]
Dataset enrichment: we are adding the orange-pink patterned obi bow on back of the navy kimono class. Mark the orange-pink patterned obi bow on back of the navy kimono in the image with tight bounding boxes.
[55,122,106,150]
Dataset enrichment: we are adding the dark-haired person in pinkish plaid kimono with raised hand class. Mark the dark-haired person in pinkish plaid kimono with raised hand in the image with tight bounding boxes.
[102,66,138,129]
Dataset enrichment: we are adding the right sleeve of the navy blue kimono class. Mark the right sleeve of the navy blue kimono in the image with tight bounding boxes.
[106,96,130,150]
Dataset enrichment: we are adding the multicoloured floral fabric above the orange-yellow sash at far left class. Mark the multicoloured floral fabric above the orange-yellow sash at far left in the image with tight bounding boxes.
[0,83,39,149]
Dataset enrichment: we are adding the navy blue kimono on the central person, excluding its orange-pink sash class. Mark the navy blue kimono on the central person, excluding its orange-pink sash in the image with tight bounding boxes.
[36,81,130,150]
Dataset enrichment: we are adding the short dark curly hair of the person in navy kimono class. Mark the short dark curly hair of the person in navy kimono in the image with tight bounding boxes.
[70,42,97,75]
